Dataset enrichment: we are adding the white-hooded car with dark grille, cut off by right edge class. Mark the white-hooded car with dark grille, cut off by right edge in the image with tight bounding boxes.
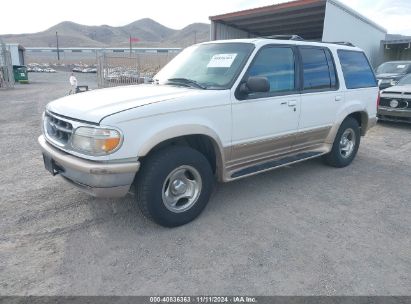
[378,74,411,123]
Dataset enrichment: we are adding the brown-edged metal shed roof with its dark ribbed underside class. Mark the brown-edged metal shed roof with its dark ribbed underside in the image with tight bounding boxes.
[210,0,385,40]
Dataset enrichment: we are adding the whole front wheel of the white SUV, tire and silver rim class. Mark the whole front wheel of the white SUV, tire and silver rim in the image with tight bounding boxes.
[135,146,213,227]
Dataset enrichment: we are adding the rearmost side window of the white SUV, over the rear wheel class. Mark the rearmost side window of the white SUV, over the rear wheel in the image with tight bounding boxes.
[338,50,377,89]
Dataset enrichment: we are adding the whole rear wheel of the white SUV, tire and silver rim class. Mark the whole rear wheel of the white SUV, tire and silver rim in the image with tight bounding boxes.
[323,117,361,168]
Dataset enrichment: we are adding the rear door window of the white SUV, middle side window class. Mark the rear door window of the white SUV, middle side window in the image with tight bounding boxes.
[300,48,338,90]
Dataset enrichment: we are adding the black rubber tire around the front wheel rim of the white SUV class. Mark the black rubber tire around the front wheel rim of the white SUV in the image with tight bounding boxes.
[135,146,214,227]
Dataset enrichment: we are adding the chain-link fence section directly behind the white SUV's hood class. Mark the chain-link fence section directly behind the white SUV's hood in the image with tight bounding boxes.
[97,52,177,88]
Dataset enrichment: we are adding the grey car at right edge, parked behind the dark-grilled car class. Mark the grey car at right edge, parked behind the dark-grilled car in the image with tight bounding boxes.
[376,61,411,90]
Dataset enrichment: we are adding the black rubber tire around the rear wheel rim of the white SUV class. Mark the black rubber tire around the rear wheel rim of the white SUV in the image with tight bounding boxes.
[323,117,361,168]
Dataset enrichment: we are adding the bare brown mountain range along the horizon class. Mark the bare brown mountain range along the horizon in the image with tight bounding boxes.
[0,18,210,47]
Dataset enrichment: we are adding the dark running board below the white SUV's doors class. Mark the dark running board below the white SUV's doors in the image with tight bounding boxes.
[231,152,324,178]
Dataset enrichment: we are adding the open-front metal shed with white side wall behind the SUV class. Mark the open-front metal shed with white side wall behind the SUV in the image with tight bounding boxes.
[210,0,387,66]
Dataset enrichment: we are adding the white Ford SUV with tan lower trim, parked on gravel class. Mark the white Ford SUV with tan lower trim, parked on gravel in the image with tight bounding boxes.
[39,39,379,226]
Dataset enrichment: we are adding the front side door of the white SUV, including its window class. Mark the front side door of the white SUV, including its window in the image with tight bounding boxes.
[232,45,301,157]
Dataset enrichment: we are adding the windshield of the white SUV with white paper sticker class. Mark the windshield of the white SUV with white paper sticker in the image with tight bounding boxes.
[154,43,254,89]
